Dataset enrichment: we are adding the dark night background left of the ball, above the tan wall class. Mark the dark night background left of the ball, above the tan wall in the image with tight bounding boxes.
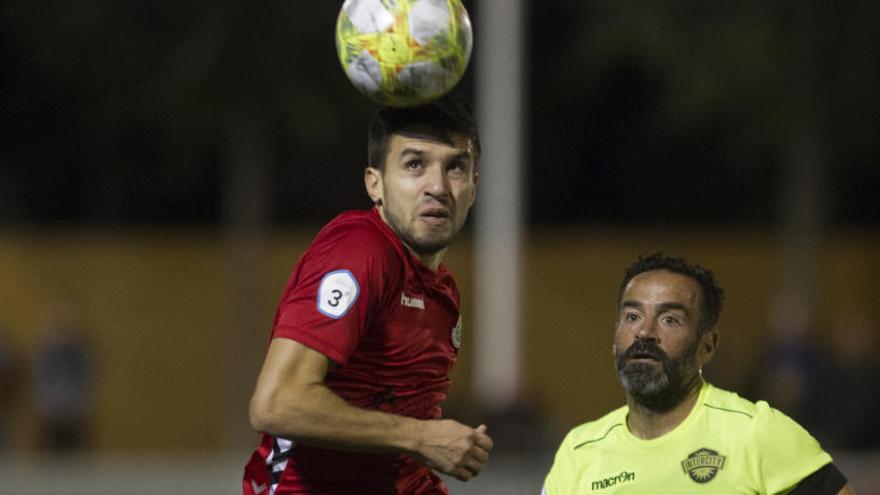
[0,0,367,226]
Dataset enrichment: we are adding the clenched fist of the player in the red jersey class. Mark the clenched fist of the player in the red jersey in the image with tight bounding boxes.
[417,419,493,481]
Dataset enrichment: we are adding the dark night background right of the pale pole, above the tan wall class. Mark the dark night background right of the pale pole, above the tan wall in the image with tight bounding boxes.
[532,0,880,224]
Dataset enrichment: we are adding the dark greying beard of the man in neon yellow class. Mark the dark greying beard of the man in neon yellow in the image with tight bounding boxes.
[615,342,700,412]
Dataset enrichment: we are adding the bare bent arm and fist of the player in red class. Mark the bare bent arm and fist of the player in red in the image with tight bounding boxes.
[250,338,492,481]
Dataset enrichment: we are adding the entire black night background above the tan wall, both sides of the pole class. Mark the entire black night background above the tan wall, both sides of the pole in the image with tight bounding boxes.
[0,0,880,228]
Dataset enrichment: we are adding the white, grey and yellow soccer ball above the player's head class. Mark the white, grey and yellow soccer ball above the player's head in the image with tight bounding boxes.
[336,0,473,107]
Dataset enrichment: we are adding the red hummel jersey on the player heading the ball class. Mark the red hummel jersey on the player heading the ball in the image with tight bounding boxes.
[244,209,461,495]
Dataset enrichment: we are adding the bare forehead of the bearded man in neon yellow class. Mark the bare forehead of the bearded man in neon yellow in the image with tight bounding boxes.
[621,270,701,308]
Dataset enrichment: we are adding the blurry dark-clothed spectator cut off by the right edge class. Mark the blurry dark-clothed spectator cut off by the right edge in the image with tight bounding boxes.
[816,313,880,450]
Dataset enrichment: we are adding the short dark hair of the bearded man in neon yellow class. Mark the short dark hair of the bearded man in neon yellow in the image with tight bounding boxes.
[617,253,724,333]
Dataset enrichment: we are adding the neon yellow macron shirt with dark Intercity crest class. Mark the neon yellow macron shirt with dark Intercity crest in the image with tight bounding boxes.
[543,383,831,495]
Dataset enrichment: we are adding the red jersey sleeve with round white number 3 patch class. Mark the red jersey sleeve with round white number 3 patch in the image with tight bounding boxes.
[272,222,403,364]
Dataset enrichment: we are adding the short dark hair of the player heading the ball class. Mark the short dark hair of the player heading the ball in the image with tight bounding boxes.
[367,93,480,170]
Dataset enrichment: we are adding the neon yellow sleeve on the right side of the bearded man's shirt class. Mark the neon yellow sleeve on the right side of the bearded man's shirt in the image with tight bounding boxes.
[755,403,831,493]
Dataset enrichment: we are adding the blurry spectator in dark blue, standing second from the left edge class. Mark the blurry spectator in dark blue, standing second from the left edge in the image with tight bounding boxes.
[34,306,93,452]
